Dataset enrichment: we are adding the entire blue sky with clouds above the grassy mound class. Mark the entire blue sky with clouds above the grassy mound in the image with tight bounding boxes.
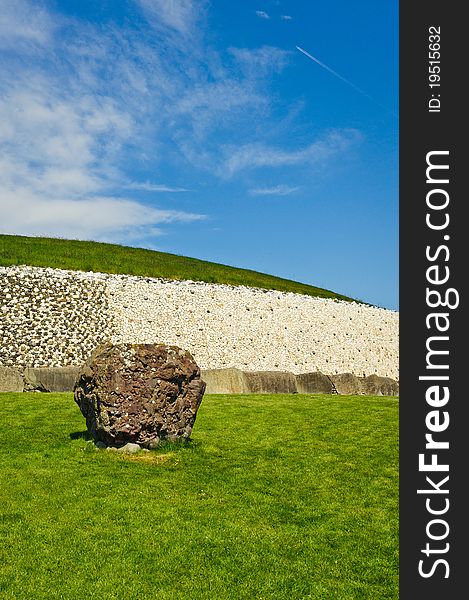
[0,0,398,309]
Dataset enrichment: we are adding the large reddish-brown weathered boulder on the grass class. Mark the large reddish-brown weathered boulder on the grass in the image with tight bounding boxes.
[74,343,205,448]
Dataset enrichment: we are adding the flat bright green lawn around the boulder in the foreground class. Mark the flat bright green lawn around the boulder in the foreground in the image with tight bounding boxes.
[0,393,398,600]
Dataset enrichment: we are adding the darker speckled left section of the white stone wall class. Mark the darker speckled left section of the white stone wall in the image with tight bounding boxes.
[0,267,113,367]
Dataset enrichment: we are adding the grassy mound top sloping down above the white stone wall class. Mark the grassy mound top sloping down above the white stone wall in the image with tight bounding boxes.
[0,235,352,301]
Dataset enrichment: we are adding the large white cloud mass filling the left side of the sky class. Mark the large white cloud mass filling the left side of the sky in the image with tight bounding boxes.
[0,0,204,241]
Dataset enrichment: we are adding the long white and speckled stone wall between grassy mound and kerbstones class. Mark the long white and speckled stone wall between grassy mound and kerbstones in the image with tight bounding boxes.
[0,267,399,380]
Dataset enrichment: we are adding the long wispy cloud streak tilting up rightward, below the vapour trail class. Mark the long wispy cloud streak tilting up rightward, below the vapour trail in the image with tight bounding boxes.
[220,129,360,177]
